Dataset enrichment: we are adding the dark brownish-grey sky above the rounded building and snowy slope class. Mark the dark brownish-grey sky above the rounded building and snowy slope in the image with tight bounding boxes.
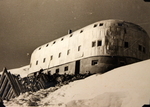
[0,0,150,71]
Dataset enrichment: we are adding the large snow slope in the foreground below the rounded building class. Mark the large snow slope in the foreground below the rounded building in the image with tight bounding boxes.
[4,60,150,107]
